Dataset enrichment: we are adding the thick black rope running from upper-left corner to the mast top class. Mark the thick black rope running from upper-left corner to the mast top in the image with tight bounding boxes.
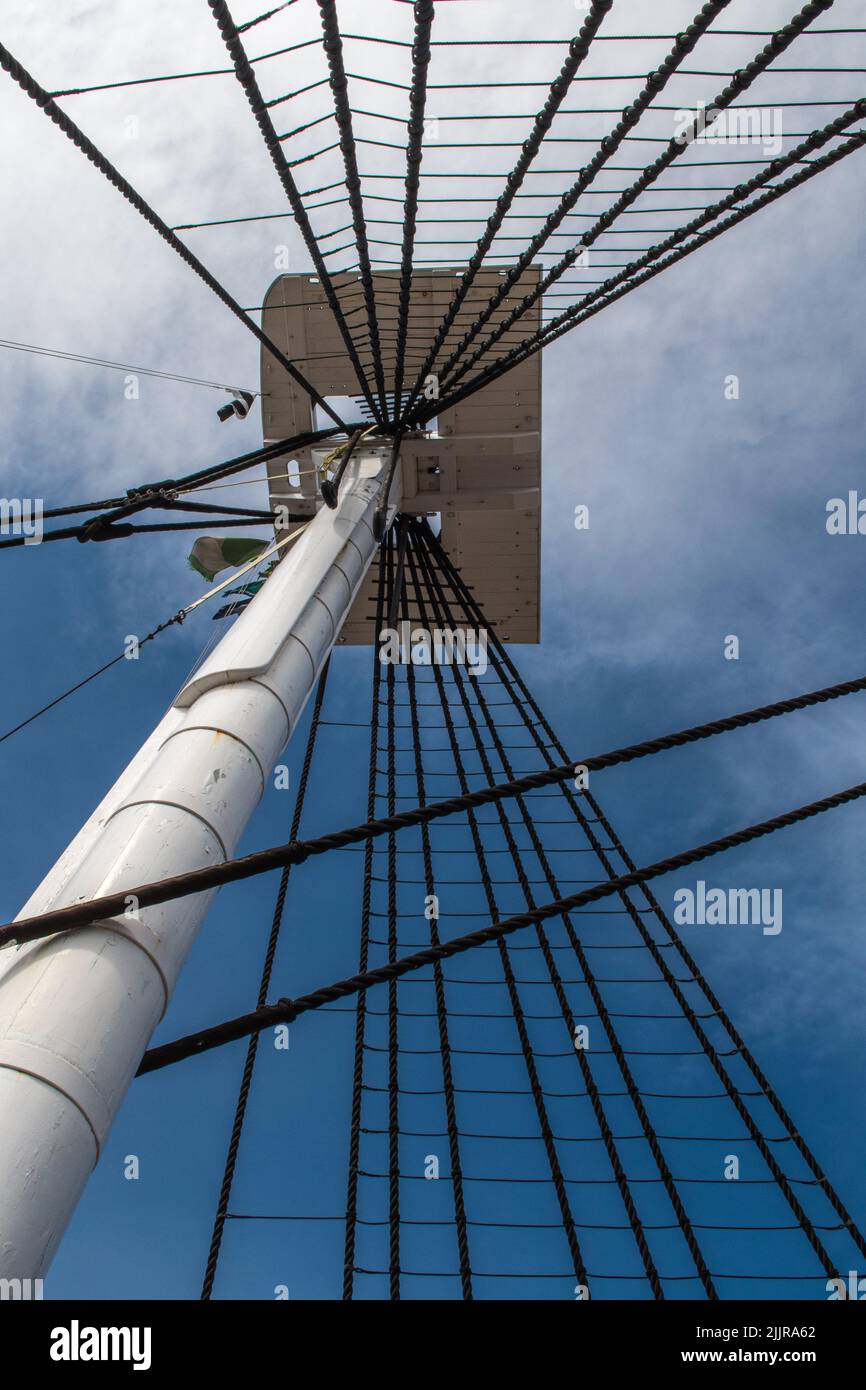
[0,43,345,430]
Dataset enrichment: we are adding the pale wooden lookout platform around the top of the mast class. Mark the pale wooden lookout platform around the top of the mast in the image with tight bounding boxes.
[261,267,541,644]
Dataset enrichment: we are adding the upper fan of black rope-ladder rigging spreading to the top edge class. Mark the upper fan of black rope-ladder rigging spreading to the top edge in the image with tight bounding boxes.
[38,0,859,436]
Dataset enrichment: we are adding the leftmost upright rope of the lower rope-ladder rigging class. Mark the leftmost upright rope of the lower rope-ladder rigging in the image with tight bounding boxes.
[343,550,385,1301]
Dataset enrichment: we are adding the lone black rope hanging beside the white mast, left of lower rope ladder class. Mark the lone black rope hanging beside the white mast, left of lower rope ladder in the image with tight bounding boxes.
[202,662,329,1300]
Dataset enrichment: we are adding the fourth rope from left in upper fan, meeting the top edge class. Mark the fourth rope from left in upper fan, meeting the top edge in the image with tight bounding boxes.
[398,0,614,421]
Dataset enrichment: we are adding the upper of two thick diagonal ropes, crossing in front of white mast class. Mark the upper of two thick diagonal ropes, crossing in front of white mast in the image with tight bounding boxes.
[13,653,866,948]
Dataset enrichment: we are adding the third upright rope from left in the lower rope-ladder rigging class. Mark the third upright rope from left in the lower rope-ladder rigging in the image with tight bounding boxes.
[402,546,473,1300]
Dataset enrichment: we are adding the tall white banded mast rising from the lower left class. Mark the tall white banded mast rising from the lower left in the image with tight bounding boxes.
[0,448,400,1279]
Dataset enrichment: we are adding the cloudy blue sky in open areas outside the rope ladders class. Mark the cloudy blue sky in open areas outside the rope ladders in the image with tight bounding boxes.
[0,0,866,1298]
